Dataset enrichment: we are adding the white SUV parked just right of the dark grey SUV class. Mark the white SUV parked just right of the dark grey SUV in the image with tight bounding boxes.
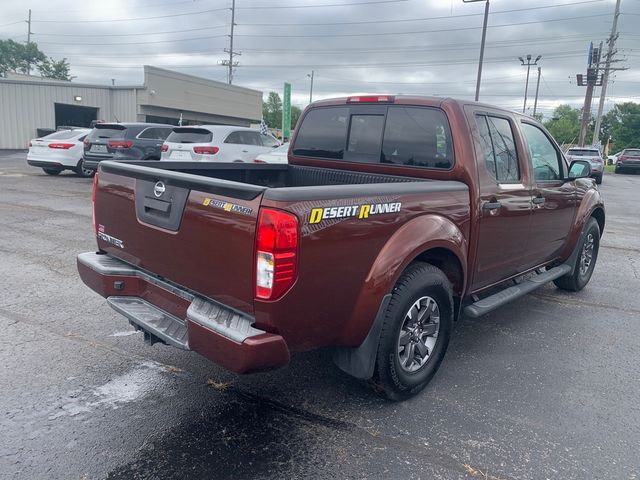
[161,125,280,162]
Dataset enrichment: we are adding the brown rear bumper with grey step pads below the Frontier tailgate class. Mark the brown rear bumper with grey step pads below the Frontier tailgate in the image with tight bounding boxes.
[77,252,289,373]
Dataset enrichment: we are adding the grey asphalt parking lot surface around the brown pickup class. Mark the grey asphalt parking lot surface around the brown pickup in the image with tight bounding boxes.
[0,152,640,480]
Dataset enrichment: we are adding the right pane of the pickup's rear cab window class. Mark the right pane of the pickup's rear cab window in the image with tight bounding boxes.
[381,106,453,170]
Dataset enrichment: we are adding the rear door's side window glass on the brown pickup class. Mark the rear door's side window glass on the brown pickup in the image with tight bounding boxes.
[476,115,520,183]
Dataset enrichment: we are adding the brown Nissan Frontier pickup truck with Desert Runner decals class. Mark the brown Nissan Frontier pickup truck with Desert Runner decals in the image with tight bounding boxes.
[78,96,605,400]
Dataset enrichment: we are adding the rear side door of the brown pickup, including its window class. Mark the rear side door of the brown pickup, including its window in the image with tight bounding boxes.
[470,111,531,290]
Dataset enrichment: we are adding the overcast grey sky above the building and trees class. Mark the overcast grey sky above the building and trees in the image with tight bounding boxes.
[0,0,640,116]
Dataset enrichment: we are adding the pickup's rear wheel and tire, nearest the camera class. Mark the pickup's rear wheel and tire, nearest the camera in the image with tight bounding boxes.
[372,263,453,401]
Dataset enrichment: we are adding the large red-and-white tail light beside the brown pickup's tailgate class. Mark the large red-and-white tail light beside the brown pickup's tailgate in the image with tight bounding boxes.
[255,208,298,300]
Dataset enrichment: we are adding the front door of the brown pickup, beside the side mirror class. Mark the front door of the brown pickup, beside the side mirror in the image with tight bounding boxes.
[521,121,576,264]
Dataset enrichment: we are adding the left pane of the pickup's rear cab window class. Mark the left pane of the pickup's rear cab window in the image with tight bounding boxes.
[293,107,349,159]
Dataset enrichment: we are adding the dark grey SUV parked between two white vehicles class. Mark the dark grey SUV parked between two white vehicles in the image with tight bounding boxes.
[82,123,173,168]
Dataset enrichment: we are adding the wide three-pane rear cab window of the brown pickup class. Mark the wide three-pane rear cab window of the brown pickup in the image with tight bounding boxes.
[292,104,454,170]
